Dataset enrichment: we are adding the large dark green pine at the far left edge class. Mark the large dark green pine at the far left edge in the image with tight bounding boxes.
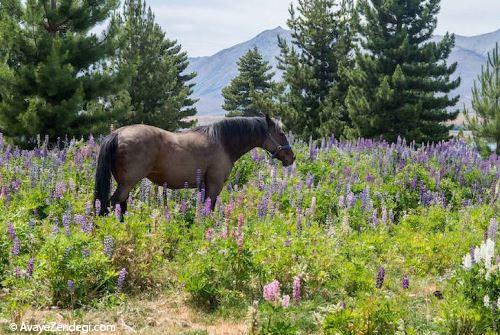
[0,0,121,146]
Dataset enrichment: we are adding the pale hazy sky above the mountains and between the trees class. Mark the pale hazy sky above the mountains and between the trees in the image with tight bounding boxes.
[146,0,500,57]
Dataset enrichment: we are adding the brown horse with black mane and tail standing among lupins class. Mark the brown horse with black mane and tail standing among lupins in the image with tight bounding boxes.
[94,116,295,215]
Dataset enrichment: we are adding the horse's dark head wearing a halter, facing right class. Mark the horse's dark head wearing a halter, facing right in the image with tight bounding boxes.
[263,115,295,166]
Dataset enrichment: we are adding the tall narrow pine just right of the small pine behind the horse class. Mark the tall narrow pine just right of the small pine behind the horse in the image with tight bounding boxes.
[278,0,356,139]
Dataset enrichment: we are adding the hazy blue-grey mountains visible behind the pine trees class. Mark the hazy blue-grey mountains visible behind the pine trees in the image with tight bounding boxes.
[186,27,500,116]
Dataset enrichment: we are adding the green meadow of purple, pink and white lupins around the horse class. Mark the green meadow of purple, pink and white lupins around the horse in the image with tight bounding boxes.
[0,133,500,334]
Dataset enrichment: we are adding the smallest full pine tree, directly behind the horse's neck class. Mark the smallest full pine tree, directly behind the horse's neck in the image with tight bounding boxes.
[222,48,275,116]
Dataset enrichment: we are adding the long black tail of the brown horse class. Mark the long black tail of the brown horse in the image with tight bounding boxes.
[94,133,118,215]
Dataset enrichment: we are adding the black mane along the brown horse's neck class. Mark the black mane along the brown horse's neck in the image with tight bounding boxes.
[192,117,269,156]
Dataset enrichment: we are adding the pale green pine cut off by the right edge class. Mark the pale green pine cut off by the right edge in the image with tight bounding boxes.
[466,43,500,156]
